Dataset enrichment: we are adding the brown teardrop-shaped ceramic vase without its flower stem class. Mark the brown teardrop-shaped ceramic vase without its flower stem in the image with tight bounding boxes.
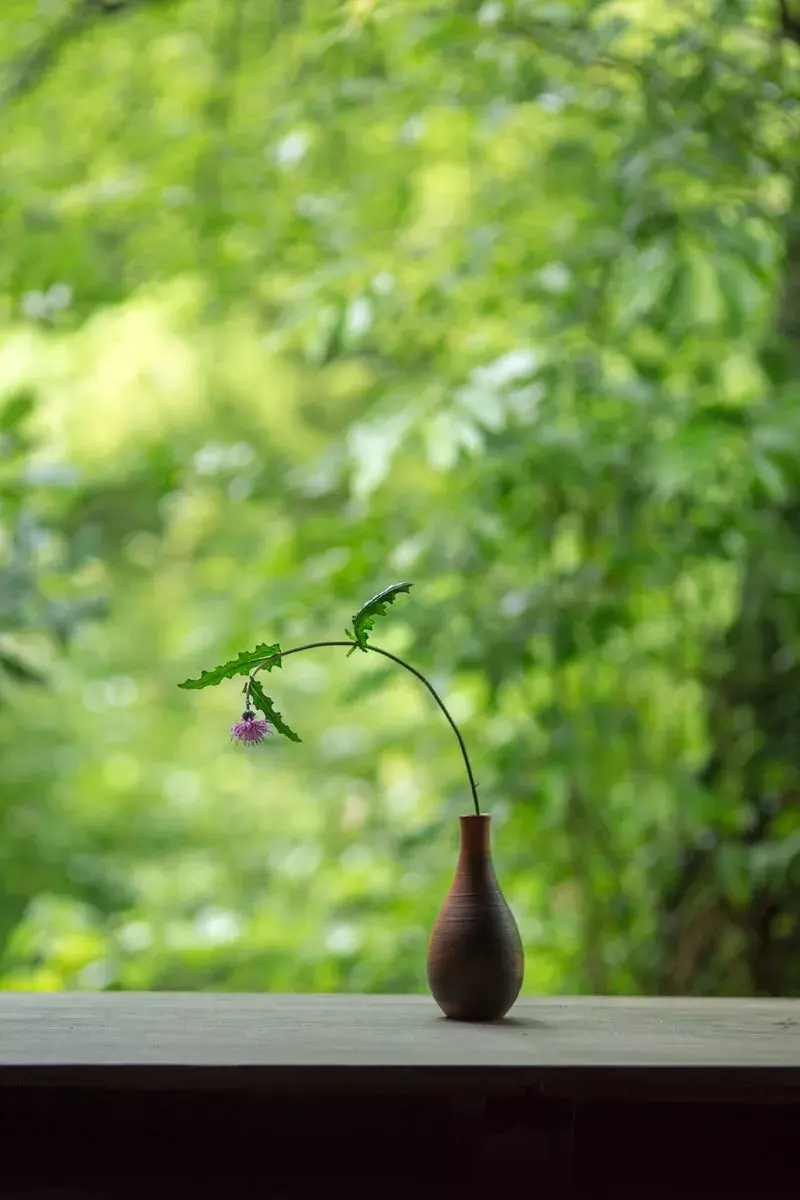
[428,816,525,1021]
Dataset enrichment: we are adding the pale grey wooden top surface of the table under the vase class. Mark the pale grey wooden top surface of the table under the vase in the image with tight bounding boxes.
[0,992,800,1086]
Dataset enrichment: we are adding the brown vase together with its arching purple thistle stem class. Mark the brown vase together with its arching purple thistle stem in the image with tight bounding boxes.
[180,583,524,1021]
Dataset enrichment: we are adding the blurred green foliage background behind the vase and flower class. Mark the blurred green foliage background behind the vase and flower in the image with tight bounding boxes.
[0,0,800,995]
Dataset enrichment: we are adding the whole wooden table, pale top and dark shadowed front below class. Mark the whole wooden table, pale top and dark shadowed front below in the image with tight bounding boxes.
[0,992,800,1200]
